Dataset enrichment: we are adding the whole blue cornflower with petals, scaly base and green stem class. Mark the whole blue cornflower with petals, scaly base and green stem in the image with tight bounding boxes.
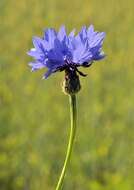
[28,25,105,190]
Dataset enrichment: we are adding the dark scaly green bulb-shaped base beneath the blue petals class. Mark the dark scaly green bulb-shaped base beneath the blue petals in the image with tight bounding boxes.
[62,69,81,95]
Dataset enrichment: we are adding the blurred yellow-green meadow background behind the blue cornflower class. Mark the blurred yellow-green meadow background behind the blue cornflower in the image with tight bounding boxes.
[0,0,134,190]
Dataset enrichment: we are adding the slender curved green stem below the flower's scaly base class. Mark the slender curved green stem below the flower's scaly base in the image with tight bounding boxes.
[56,95,77,190]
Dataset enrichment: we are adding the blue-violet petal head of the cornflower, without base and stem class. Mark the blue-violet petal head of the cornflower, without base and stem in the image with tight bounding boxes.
[28,25,105,78]
